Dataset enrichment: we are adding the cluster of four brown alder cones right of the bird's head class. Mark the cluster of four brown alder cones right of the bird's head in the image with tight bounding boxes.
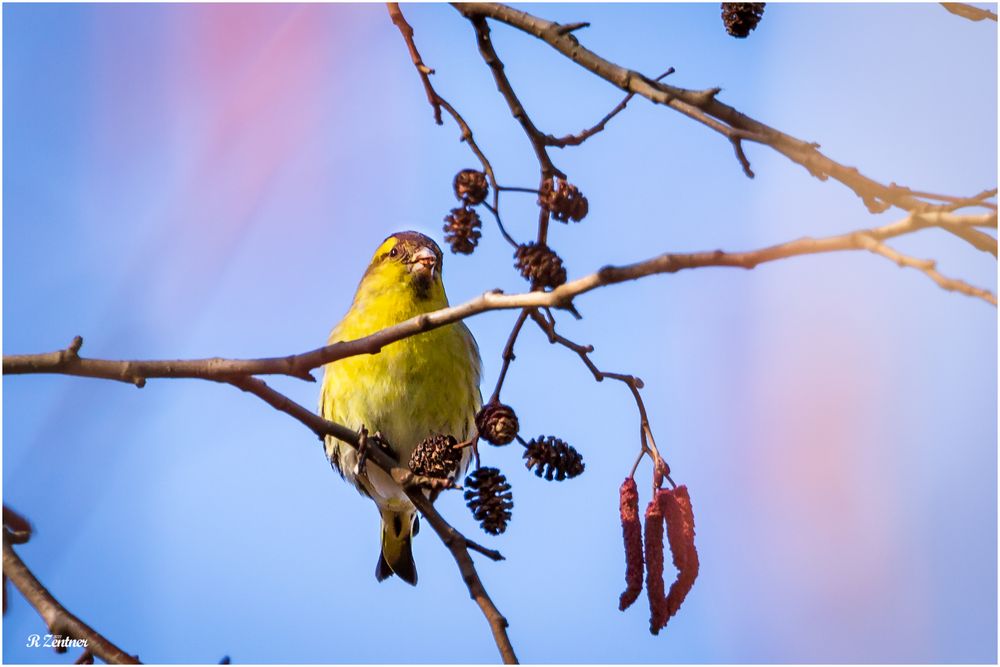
[444,169,590,290]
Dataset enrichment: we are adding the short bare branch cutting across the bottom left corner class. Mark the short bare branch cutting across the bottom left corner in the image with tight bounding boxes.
[3,528,139,665]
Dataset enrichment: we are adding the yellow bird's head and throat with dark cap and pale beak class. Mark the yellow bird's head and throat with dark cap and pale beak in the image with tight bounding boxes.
[358,232,447,308]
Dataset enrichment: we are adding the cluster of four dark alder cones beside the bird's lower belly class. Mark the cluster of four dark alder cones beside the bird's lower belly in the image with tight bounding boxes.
[409,401,585,535]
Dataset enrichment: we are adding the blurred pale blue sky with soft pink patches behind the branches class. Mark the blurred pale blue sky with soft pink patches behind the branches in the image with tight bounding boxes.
[3,4,997,663]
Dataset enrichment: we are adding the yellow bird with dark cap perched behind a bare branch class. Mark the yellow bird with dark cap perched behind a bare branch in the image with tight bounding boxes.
[319,231,482,586]
